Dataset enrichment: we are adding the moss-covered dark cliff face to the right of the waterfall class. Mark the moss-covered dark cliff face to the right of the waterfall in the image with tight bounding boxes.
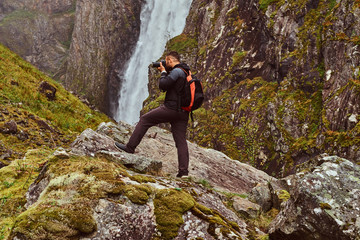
[147,0,360,175]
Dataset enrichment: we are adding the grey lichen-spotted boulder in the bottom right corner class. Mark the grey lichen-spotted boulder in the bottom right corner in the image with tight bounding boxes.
[269,156,360,240]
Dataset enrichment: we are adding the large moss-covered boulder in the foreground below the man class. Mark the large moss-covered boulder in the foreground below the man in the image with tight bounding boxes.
[8,144,248,240]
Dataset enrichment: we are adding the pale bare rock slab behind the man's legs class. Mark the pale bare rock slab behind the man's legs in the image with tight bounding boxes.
[97,122,277,194]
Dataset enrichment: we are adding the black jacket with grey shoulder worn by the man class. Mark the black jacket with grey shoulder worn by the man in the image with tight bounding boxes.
[159,63,190,111]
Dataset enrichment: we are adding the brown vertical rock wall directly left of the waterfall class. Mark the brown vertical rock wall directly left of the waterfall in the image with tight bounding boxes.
[65,0,142,113]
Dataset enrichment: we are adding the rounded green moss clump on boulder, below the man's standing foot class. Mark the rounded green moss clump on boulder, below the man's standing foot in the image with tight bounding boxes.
[154,189,195,239]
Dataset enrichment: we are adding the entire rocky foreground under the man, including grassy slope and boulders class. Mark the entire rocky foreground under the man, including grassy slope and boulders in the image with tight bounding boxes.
[0,45,360,240]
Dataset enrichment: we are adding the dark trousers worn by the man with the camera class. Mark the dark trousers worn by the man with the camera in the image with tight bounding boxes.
[126,106,189,172]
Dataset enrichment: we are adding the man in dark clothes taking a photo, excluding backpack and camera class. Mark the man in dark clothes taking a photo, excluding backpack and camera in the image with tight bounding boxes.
[115,51,190,177]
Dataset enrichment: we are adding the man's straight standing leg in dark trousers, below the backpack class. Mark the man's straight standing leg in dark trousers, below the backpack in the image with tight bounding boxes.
[171,113,189,177]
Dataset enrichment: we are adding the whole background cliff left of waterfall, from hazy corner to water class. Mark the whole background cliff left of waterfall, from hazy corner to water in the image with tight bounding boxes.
[0,0,142,113]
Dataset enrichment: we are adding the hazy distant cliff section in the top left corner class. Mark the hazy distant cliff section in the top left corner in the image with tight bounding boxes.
[0,0,76,76]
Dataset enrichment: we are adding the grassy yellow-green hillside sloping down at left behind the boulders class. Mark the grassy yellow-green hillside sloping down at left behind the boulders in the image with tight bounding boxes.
[0,45,108,163]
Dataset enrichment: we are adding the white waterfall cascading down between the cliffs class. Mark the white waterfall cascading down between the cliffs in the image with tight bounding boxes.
[115,0,192,124]
